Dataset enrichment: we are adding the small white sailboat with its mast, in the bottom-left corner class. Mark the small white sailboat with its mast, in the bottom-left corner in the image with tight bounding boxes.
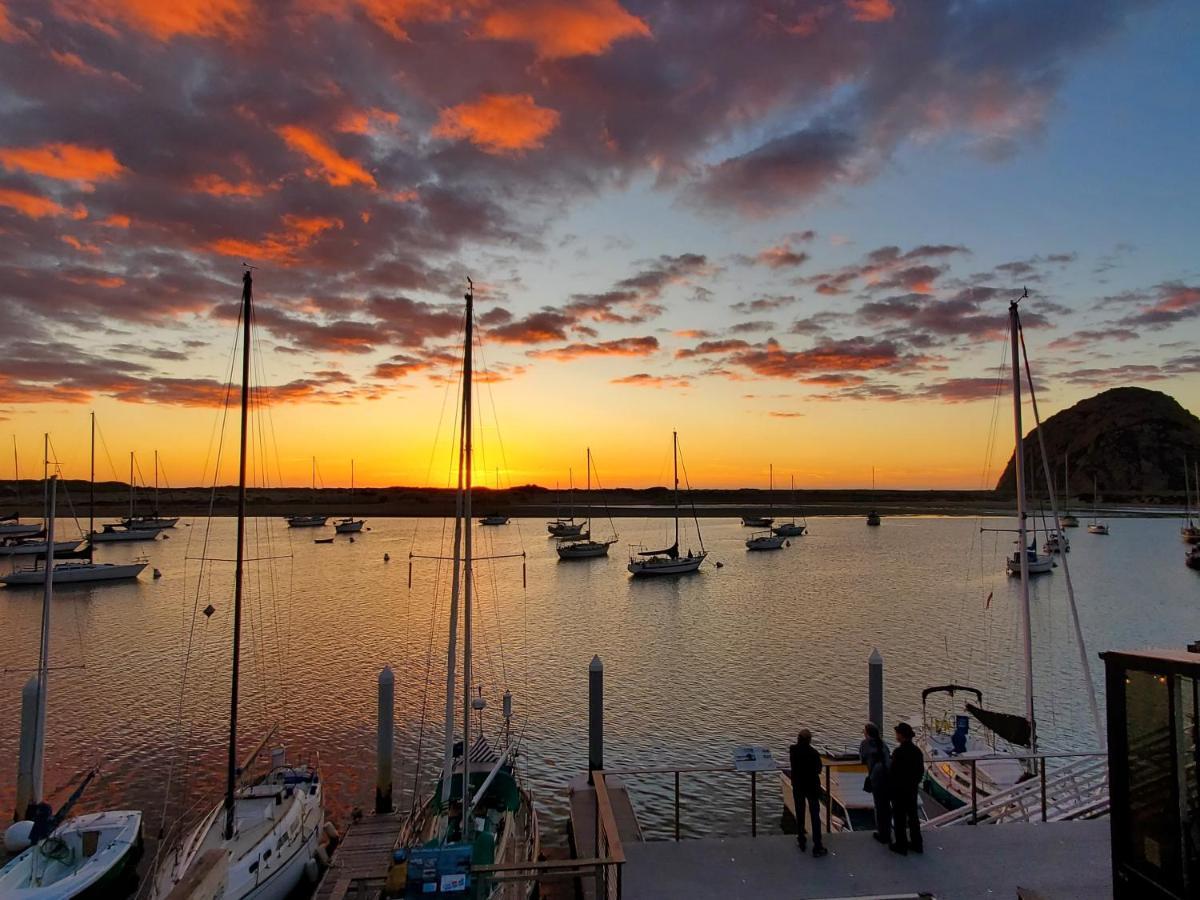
[0,475,142,900]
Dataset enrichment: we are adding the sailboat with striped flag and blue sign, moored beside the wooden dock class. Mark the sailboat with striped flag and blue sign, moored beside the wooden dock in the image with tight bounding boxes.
[397,280,539,900]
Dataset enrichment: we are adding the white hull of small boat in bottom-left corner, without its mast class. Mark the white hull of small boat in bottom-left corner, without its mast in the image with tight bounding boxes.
[0,810,142,900]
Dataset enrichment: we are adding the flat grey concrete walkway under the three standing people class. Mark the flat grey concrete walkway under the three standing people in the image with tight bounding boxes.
[623,821,1112,900]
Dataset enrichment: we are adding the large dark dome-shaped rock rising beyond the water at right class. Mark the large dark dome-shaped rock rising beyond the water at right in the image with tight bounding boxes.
[996,388,1200,498]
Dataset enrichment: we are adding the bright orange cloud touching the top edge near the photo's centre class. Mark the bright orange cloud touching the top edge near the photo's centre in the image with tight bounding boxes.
[482,0,650,59]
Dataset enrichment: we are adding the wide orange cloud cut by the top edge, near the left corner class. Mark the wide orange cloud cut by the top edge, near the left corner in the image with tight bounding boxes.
[54,0,252,41]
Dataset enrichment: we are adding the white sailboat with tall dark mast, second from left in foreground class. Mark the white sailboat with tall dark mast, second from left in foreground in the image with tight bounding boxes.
[150,270,325,900]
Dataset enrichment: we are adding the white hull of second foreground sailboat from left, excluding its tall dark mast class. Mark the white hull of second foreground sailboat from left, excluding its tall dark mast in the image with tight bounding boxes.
[150,767,324,900]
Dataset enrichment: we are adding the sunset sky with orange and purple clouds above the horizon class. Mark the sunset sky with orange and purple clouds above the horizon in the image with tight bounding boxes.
[0,0,1200,487]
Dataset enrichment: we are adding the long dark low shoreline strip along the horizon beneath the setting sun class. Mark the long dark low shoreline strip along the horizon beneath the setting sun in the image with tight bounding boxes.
[0,480,1183,520]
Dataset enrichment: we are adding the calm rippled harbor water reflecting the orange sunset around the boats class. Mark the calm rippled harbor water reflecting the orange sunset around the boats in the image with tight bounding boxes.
[0,516,1200,864]
